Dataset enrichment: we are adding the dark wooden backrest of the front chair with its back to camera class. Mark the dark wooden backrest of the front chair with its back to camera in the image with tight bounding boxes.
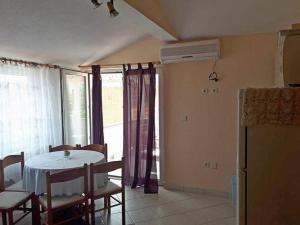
[46,164,88,209]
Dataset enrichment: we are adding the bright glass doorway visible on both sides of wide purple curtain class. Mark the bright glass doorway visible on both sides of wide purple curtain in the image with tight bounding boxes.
[102,72,160,178]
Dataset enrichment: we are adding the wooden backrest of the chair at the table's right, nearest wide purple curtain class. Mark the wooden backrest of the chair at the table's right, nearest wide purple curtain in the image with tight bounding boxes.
[90,158,124,193]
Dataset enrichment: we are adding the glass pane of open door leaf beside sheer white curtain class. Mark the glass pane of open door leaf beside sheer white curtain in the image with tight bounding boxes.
[64,74,89,146]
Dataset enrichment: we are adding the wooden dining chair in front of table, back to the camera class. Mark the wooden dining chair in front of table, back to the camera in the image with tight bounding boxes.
[39,164,89,225]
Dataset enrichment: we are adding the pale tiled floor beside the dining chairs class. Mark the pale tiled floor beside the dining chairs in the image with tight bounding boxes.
[2,188,236,225]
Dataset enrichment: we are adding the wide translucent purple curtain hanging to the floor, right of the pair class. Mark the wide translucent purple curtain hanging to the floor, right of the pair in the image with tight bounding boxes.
[123,63,158,193]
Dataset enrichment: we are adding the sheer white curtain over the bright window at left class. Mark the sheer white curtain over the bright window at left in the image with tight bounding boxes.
[0,64,62,162]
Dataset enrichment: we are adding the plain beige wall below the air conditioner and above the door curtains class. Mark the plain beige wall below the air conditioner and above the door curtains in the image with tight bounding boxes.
[95,34,276,192]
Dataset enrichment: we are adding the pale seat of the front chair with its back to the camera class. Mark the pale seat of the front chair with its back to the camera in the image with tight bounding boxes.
[39,195,85,209]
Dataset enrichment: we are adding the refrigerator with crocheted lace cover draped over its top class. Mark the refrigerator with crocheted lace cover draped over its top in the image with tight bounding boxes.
[238,88,300,225]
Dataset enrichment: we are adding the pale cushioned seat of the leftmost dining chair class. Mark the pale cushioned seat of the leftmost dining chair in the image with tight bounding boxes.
[0,191,32,209]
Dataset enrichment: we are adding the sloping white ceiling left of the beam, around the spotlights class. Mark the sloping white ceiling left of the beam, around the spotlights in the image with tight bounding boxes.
[0,0,156,66]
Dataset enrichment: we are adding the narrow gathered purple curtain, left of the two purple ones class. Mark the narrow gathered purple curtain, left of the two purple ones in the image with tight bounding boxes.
[92,65,104,145]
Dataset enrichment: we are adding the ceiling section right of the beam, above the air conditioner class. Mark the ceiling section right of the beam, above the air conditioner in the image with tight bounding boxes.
[162,0,300,39]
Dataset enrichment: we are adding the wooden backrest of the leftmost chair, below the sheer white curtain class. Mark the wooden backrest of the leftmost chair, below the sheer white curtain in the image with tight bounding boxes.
[0,152,24,191]
